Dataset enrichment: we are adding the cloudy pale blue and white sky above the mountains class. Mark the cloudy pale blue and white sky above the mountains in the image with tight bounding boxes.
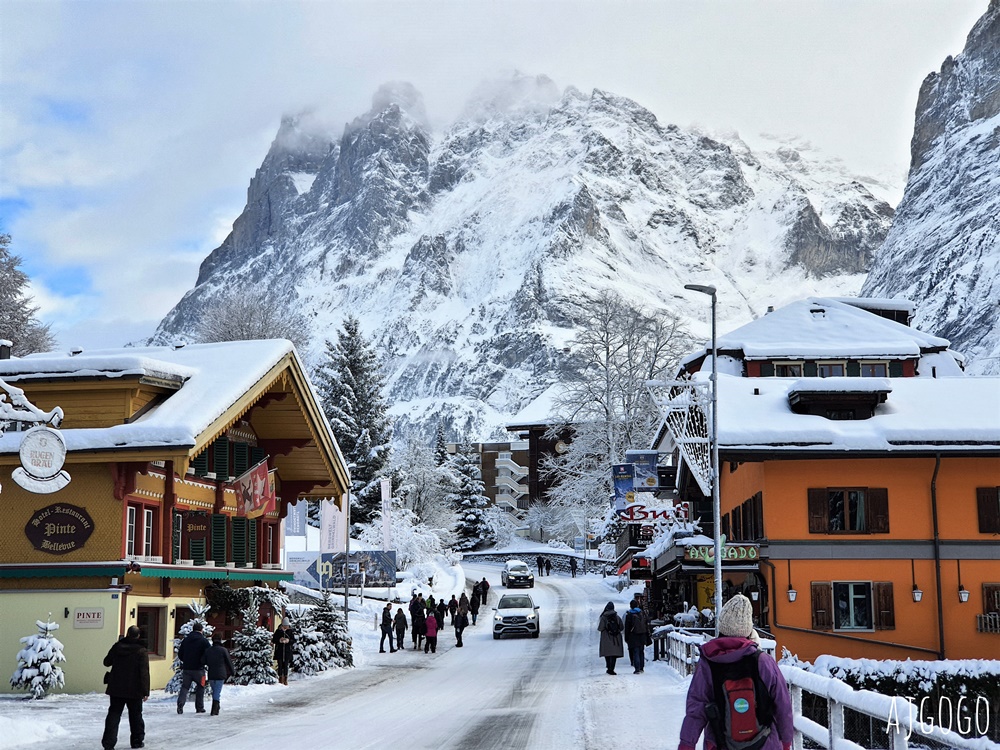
[0,0,987,348]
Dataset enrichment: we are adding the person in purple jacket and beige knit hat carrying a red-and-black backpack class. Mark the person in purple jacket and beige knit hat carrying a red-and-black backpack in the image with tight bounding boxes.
[678,594,795,750]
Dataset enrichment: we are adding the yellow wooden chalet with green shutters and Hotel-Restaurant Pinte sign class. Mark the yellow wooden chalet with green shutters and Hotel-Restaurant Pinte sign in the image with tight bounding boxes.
[0,340,348,693]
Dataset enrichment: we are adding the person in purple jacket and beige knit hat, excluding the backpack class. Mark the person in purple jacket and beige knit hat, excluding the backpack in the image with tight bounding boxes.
[678,594,795,750]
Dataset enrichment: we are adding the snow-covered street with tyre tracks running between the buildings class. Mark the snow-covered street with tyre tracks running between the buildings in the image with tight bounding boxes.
[0,565,687,750]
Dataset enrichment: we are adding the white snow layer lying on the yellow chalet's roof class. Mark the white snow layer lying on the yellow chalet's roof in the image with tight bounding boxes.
[0,339,295,453]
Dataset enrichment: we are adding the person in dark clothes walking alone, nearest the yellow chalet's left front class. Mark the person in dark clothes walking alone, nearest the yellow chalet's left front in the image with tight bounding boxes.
[101,625,149,750]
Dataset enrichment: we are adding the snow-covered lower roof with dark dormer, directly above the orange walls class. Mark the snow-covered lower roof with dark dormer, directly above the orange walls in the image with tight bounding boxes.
[708,373,1000,452]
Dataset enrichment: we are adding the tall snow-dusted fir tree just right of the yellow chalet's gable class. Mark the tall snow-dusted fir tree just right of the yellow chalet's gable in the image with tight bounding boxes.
[310,316,392,524]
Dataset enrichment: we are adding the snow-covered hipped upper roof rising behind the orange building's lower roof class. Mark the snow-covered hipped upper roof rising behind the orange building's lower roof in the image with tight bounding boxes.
[685,297,949,363]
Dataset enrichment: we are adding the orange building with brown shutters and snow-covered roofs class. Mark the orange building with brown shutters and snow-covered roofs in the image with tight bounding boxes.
[653,299,1000,659]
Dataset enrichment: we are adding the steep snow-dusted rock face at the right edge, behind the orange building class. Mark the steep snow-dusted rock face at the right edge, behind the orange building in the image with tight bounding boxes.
[863,0,1000,374]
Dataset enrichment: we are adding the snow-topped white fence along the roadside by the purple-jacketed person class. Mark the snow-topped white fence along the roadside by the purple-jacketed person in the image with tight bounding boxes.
[653,626,988,750]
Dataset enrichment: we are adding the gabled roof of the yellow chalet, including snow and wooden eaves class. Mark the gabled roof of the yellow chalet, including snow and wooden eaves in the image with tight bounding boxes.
[0,339,347,498]
